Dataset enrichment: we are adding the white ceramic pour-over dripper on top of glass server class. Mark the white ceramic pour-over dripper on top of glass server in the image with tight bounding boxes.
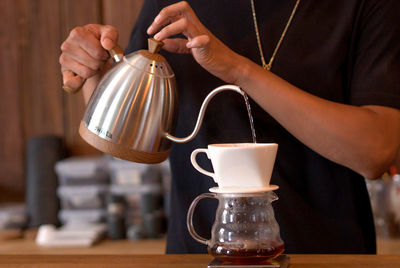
[190,143,278,193]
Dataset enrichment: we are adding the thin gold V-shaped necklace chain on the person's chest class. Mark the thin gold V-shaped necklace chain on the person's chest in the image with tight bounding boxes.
[250,0,300,71]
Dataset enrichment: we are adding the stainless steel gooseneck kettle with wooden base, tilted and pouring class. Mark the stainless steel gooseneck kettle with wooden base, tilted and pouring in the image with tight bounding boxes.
[65,39,244,163]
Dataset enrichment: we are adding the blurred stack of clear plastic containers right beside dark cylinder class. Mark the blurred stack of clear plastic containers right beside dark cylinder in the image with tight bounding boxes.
[55,156,110,225]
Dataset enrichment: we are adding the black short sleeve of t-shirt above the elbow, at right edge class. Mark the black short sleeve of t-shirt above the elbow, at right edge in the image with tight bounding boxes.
[350,0,400,108]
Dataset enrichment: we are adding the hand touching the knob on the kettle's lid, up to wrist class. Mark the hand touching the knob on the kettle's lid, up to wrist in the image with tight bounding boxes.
[147,1,243,83]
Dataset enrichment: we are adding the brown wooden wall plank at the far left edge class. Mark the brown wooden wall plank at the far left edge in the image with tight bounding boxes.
[0,0,24,202]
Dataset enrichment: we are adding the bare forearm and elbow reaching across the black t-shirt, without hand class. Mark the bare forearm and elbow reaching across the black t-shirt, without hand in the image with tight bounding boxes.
[235,58,400,178]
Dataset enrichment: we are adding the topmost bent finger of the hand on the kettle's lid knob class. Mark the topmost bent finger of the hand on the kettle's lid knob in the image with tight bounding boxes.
[148,1,199,34]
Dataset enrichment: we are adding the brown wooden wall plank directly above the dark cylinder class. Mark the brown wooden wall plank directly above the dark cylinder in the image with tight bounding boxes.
[16,0,64,138]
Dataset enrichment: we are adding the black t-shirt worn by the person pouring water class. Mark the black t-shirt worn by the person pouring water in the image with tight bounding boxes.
[127,0,400,253]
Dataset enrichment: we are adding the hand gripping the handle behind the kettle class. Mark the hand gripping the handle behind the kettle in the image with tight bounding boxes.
[59,24,118,93]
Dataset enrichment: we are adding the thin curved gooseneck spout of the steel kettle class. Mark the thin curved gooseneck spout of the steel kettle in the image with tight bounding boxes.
[165,85,245,143]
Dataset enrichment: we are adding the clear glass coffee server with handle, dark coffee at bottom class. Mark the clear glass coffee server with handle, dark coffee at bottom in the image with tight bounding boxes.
[187,191,288,267]
